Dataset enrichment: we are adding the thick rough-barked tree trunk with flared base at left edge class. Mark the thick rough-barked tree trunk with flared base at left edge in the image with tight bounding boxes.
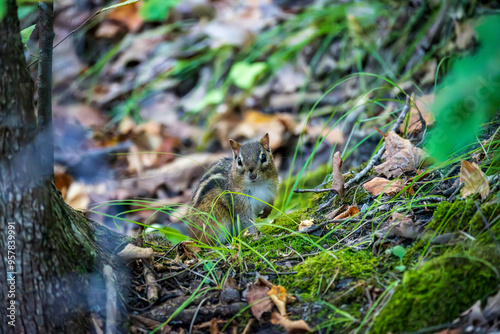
[0,0,129,333]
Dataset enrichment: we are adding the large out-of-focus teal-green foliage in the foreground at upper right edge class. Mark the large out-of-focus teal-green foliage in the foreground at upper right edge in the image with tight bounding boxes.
[426,16,500,161]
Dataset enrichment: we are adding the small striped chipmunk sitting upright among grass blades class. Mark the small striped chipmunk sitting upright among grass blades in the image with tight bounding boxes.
[188,133,278,245]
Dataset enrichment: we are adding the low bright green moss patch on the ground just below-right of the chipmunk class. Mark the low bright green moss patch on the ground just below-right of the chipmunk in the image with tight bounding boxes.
[289,250,381,295]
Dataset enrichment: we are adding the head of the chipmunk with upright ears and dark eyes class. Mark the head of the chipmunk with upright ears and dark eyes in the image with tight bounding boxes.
[229,133,277,183]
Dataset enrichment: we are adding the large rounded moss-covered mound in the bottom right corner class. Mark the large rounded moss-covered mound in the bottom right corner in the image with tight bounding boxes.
[371,253,498,333]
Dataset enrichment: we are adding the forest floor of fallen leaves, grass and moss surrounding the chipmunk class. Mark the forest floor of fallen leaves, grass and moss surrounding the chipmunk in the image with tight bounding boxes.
[19,0,500,334]
